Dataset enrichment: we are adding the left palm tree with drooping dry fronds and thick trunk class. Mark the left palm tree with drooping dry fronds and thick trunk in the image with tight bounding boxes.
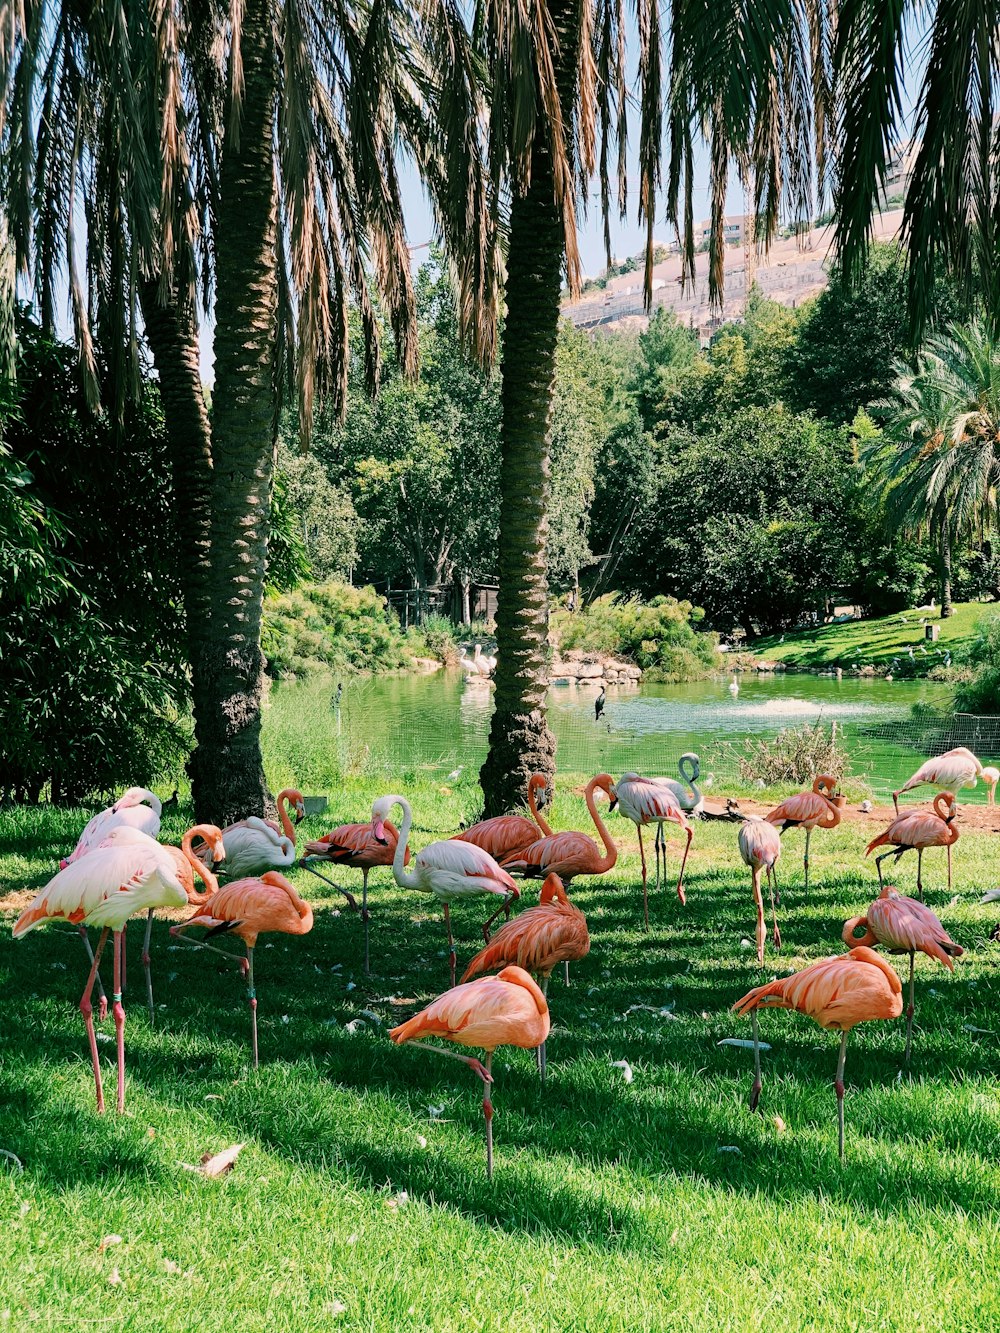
[0,0,497,822]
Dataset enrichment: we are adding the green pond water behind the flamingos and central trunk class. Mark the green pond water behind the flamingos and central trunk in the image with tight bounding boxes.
[267,672,995,800]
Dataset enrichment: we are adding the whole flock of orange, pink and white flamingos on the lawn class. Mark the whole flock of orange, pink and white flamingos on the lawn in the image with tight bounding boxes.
[5,748,1000,1176]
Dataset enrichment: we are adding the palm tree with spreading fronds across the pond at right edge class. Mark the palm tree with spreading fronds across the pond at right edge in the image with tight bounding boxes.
[863,323,1000,617]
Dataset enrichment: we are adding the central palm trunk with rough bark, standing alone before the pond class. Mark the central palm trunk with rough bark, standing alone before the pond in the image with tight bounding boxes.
[480,0,577,817]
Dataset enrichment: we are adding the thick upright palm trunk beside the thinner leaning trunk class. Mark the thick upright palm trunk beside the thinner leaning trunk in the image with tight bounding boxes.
[191,0,277,825]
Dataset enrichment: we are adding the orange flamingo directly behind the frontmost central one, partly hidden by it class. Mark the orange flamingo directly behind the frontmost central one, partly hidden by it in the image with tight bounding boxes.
[461,874,591,1084]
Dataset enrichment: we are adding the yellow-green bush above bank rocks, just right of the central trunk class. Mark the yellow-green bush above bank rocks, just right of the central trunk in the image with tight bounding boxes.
[551,592,720,682]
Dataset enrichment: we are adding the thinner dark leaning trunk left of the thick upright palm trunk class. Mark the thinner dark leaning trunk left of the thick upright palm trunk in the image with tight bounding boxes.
[139,279,212,762]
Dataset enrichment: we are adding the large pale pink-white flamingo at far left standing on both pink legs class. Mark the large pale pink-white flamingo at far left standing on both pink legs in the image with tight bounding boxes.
[13,826,188,1112]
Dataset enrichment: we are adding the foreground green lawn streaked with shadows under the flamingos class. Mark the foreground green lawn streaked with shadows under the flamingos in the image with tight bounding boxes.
[0,778,1000,1333]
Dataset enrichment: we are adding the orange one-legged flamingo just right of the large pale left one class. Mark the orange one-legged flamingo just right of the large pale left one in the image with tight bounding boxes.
[171,869,312,1069]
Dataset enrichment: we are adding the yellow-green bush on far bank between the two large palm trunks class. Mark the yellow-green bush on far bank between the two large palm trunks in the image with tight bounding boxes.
[263,583,409,677]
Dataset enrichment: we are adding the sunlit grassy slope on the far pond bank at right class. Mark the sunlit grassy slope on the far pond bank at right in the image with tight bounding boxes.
[748,601,1000,676]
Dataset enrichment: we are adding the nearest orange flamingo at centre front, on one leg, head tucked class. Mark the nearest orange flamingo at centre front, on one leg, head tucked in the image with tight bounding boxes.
[389,970,549,1180]
